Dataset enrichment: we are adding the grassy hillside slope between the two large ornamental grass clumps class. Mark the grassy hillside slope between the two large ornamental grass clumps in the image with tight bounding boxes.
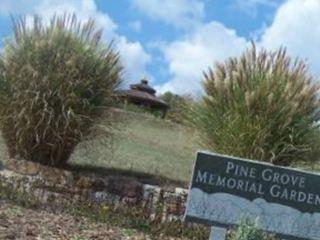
[70,109,198,183]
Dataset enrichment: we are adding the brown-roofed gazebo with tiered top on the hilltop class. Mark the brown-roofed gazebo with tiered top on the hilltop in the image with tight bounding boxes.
[117,79,169,117]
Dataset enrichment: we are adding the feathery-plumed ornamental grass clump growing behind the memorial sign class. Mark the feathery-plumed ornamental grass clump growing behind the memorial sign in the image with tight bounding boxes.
[189,44,319,165]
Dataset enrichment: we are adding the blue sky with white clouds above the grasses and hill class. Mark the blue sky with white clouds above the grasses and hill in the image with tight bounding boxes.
[0,0,320,95]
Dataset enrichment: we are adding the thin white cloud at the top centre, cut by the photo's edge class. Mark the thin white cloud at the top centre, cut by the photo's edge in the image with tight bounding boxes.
[132,0,204,28]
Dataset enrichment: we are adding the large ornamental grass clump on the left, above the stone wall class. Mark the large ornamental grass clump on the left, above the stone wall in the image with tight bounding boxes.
[0,14,122,165]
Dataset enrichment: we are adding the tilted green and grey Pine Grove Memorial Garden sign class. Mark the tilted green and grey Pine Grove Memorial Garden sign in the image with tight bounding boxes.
[185,152,320,240]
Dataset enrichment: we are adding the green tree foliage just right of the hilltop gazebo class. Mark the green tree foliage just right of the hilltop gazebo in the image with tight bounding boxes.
[159,91,193,123]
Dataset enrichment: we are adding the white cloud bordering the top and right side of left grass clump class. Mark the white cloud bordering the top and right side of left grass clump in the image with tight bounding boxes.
[0,0,151,83]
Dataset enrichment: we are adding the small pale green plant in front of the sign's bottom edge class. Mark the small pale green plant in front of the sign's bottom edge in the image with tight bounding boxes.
[229,221,276,240]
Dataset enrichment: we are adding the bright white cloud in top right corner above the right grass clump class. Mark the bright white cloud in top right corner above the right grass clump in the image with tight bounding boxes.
[261,0,320,76]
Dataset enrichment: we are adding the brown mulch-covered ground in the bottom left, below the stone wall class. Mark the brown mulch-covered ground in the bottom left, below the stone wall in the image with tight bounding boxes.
[0,202,185,240]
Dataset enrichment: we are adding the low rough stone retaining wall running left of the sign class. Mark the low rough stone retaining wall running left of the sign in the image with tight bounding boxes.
[0,159,188,222]
